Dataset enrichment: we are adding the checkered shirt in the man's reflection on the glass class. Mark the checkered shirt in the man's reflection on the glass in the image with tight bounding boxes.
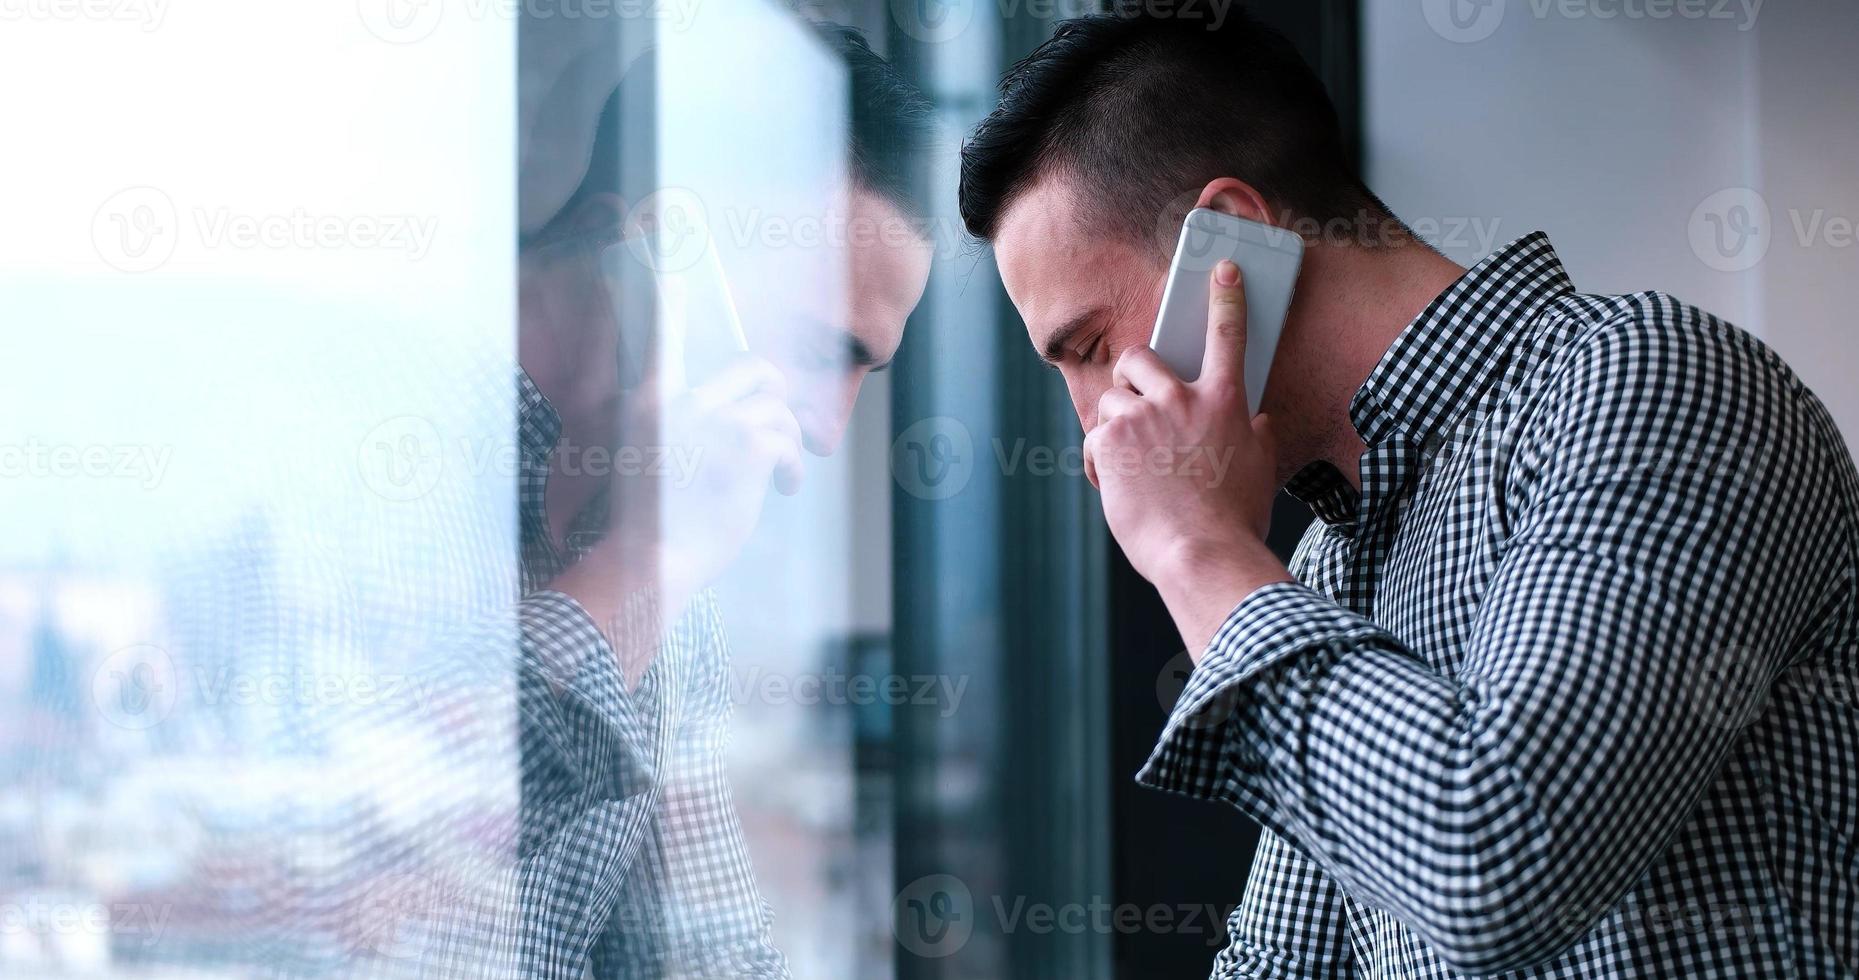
[517,376,788,980]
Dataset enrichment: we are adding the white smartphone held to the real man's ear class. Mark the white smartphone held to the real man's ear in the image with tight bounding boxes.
[1149,208,1303,415]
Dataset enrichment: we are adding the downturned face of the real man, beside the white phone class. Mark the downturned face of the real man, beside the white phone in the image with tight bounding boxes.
[995,177,1167,431]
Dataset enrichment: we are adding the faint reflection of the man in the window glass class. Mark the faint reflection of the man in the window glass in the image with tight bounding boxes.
[519,30,931,978]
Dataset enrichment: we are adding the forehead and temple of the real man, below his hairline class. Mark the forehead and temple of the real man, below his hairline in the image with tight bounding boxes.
[995,177,1162,346]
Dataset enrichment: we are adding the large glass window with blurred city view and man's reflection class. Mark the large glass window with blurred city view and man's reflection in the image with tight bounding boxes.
[0,0,1353,980]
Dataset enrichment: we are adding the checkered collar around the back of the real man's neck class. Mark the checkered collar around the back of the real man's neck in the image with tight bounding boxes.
[1350,232,1575,446]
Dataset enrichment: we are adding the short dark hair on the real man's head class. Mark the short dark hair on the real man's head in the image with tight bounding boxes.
[961,9,1391,255]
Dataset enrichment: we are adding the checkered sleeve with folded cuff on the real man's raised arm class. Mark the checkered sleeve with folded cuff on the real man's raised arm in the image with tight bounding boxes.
[1140,322,1852,976]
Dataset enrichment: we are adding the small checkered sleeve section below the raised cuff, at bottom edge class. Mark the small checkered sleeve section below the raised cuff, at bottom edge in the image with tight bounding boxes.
[1212,831,1355,980]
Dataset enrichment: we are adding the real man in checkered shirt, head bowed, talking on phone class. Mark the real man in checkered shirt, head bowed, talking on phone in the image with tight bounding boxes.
[961,9,1859,976]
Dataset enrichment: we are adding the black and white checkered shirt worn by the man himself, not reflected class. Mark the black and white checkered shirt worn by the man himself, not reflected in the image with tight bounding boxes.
[1140,234,1859,978]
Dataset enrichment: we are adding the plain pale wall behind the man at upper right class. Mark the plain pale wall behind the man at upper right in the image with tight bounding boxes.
[1363,0,1859,444]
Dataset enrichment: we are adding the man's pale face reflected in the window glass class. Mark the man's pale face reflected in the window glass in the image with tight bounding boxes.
[749,188,931,456]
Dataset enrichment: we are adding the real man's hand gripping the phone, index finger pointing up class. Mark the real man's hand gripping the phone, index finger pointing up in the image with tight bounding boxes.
[1084,262,1290,660]
